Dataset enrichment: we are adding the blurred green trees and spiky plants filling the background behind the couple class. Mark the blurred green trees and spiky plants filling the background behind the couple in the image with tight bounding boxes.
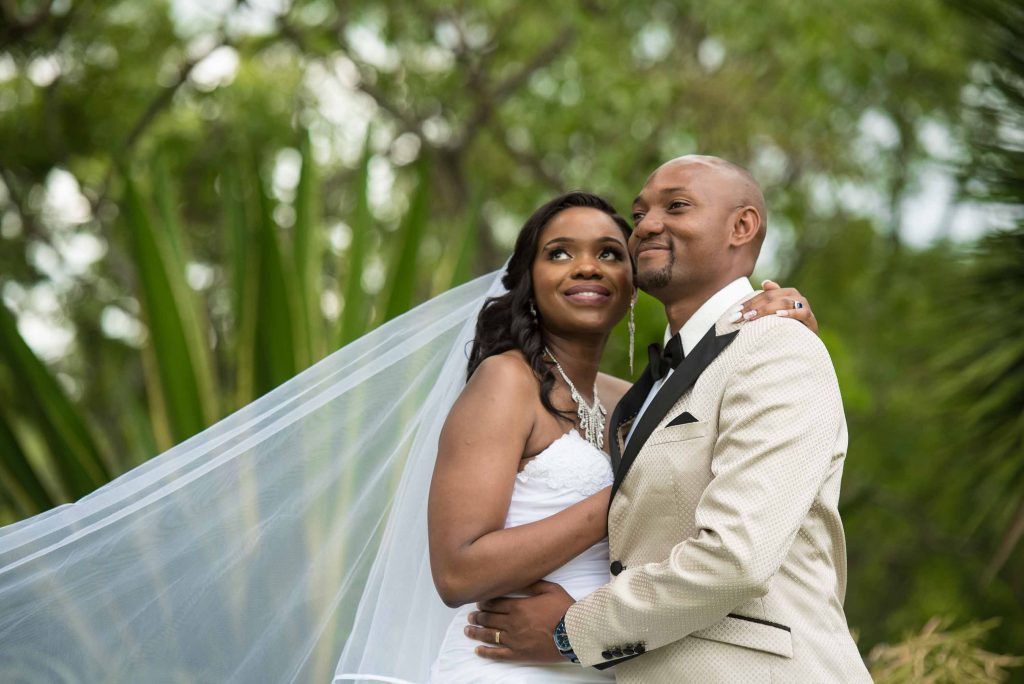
[0,0,1024,681]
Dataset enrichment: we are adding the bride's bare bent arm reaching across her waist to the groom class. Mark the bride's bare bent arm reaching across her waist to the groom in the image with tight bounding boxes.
[427,355,608,606]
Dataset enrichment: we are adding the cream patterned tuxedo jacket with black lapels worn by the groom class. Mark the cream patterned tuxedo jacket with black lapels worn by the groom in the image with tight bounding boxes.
[565,295,870,684]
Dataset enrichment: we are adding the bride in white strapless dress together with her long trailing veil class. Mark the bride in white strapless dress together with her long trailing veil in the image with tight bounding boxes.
[0,196,815,682]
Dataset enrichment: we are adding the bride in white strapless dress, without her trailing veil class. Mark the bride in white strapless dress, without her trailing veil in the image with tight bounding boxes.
[428,193,635,682]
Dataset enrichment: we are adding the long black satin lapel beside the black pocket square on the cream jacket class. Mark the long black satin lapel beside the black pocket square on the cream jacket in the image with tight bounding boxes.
[611,328,739,499]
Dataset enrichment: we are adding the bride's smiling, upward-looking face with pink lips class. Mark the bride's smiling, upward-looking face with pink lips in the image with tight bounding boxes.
[532,207,633,334]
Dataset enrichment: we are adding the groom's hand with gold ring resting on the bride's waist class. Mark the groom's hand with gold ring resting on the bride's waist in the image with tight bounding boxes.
[466,581,575,662]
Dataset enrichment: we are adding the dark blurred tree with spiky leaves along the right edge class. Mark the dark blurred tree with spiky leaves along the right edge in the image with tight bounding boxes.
[946,0,1024,602]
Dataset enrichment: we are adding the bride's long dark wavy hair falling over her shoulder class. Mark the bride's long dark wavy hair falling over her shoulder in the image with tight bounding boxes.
[466,190,632,416]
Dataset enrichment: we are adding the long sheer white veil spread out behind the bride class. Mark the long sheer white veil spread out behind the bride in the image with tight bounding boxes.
[0,272,504,684]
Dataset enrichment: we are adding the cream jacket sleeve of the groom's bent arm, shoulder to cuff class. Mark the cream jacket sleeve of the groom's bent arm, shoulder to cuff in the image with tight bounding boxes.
[565,320,846,665]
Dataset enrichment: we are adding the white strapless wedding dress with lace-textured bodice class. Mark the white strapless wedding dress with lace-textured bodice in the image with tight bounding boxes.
[430,430,614,684]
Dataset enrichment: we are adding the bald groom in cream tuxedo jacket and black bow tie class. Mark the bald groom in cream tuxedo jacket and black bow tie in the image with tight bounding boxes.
[467,156,870,684]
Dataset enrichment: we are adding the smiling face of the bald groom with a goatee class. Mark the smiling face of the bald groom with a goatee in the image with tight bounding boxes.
[630,159,734,302]
